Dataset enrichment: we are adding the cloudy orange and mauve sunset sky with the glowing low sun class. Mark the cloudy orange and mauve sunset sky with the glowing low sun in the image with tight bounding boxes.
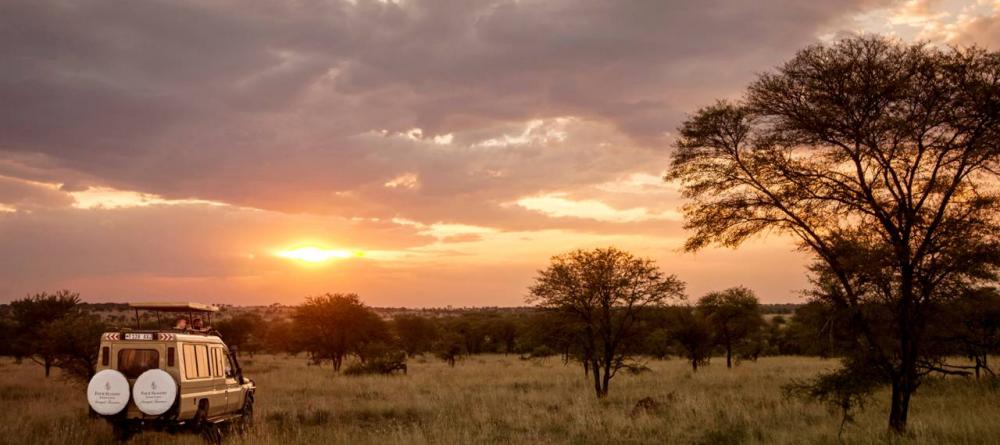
[0,0,1000,307]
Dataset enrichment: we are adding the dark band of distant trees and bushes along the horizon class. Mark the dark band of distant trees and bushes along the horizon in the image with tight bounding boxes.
[0,284,1000,386]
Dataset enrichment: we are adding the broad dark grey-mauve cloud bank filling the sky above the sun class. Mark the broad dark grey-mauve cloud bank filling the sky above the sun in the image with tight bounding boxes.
[0,0,892,223]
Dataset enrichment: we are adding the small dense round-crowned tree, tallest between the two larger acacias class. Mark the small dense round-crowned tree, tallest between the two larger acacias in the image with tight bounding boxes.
[698,286,764,369]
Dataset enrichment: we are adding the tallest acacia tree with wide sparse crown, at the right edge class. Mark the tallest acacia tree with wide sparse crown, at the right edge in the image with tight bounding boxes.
[667,37,1000,432]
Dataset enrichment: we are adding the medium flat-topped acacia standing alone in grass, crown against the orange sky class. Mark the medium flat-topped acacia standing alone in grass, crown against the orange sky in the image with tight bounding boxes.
[528,247,684,398]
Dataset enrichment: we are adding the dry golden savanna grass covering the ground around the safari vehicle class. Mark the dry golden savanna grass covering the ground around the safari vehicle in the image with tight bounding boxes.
[0,355,1000,445]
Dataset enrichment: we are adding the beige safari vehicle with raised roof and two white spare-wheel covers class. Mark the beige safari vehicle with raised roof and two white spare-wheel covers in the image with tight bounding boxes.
[87,303,256,442]
